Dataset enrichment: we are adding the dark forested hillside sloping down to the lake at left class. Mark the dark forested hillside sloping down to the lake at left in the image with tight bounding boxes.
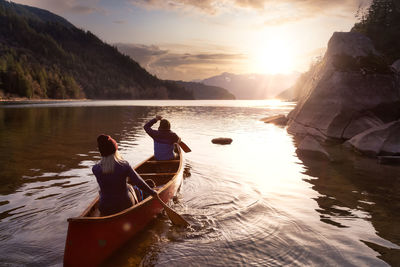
[0,0,193,99]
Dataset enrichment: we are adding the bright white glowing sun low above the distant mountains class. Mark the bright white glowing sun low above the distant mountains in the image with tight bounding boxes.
[251,37,294,74]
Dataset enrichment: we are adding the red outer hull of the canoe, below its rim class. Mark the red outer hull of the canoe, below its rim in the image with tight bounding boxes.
[64,152,183,266]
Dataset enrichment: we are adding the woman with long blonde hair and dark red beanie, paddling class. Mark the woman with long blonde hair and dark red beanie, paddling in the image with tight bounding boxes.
[92,134,157,216]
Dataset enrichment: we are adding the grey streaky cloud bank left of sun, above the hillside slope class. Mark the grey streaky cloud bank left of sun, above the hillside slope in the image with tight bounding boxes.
[116,43,247,80]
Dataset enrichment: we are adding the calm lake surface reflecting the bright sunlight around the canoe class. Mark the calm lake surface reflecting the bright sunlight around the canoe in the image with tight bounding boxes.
[0,101,400,266]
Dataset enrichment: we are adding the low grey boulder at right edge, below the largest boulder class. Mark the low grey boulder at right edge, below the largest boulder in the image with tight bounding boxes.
[348,120,400,156]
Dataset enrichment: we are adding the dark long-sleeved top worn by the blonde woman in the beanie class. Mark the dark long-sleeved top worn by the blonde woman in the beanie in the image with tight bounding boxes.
[92,161,156,216]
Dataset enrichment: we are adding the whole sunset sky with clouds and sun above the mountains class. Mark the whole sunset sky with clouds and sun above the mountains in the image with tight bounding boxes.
[13,0,371,81]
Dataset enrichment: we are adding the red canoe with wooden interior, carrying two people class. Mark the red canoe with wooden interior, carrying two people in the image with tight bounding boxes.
[64,149,183,266]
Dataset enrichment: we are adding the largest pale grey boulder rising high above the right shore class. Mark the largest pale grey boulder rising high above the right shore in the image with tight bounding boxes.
[288,32,400,141]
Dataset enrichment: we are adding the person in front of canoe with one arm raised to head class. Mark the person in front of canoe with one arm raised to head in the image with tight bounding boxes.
[143,115,180,160]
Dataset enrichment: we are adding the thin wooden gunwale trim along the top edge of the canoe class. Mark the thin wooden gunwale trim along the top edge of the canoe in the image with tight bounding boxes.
[67,148,183,222]
